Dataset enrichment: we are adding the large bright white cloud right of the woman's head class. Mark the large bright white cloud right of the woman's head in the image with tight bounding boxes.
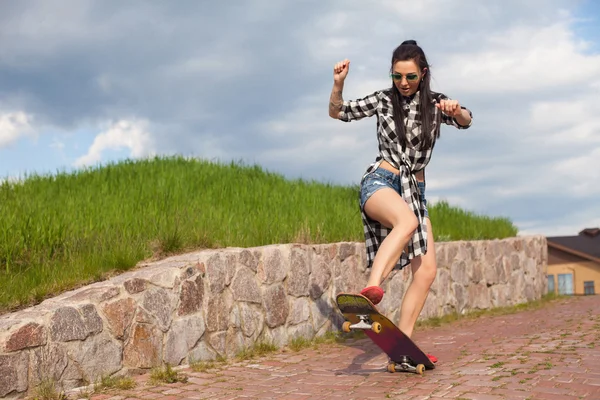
[436,20,600,96]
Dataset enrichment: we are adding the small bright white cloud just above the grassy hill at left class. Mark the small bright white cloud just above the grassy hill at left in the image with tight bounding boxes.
[74,120,156,167]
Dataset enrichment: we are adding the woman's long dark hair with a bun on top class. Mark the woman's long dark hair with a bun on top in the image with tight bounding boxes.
[390,40,439,150]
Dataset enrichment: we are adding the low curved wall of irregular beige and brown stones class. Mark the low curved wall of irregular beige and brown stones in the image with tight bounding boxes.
[0,237,547,397]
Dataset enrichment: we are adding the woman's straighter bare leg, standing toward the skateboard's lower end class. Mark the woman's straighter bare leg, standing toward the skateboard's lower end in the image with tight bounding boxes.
[398,218,437,337]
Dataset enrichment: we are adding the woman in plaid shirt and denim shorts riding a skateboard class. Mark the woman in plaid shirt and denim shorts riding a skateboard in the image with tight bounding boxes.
[329,40,472,359]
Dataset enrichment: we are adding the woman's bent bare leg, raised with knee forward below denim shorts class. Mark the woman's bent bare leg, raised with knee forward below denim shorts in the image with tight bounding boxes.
[365,188,418,286]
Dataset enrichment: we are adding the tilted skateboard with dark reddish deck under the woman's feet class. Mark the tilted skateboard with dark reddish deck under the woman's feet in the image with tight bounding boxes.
[336,293,435,375]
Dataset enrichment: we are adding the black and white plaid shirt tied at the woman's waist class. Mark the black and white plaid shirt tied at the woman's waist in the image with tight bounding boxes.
[338,89,473,268]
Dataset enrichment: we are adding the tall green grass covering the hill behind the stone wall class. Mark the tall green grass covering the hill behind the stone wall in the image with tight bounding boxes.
[0,157,517,313]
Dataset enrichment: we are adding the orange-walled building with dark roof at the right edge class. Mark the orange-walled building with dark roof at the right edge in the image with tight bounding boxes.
[546,228,600,295]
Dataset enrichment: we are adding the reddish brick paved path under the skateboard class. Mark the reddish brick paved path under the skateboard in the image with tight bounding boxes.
[79,296,600,400]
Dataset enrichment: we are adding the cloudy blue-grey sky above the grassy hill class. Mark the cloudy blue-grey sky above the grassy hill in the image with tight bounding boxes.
[0,0,600,236]
